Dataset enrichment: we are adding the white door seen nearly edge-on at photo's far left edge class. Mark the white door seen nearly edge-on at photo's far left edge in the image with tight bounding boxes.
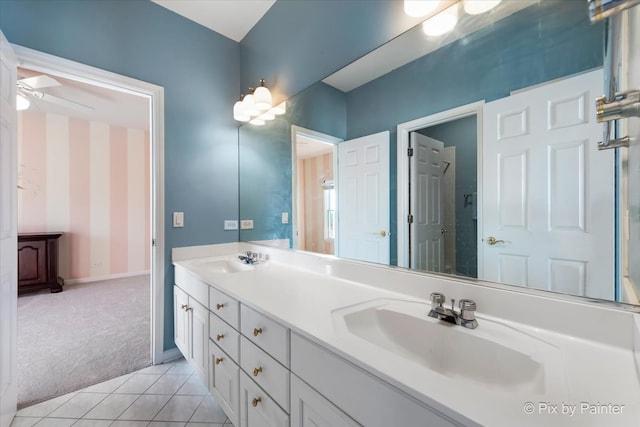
[0,31,18,427]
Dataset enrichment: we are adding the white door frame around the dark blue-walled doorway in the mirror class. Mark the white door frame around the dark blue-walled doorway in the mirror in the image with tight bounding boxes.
[397,101,484,268]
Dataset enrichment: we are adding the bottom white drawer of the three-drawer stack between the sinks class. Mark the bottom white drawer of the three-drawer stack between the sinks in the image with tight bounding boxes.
[240,371,289,427]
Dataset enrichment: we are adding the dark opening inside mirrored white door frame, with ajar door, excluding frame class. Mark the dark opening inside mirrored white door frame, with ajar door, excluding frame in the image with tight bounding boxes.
[409,115,478,277]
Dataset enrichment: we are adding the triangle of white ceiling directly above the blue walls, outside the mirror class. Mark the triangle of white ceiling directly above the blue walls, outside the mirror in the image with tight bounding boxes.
[151,0,276,42]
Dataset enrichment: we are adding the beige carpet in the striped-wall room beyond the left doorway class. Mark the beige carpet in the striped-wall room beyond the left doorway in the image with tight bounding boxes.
[18,275,151,408]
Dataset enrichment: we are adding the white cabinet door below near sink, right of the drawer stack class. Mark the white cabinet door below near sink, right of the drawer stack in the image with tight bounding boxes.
[291,375,360,427]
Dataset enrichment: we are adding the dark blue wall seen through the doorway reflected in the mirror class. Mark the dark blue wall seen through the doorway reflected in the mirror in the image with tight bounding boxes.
[418,115,478,277]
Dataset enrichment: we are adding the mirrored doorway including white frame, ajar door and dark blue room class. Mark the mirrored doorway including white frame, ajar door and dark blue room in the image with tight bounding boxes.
[397,102,484,272]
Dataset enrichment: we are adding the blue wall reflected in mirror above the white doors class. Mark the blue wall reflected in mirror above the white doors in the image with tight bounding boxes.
[347,0,603,263]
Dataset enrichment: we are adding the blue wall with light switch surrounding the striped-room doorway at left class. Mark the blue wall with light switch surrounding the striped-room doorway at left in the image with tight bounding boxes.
[0,0,240,349]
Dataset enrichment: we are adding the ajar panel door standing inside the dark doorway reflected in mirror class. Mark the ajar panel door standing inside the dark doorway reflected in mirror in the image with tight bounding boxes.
[410,132,445,272]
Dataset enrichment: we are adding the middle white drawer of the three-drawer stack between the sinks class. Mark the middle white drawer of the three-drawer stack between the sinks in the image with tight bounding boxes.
[240,337,289,411]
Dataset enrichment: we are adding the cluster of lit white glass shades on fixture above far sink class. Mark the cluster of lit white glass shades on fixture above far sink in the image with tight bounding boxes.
[233,79,287,126]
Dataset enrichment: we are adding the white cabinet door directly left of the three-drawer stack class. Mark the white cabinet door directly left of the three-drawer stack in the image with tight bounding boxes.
[209,340,240,426]
